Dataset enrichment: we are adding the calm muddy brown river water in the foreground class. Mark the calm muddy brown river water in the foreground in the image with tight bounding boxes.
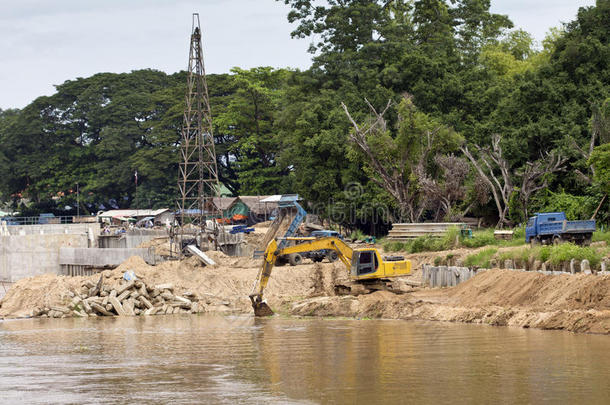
[0,315,610,404]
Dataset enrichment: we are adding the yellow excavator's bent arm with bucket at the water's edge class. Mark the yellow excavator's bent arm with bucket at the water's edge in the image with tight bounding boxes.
[250,237,354,316]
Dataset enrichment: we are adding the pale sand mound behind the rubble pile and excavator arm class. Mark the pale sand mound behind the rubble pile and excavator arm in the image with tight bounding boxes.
[0,252,337,318]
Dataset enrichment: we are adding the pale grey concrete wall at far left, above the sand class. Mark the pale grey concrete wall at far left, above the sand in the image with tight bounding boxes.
[0,234,89,282]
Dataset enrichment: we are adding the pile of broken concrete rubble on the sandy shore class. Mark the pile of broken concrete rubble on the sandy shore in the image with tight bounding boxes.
[32,275,204,318]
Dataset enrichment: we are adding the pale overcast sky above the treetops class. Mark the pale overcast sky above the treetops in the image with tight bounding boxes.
[0,0,595,109]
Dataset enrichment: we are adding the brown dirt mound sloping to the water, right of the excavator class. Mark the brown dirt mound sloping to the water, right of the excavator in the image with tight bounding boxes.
[290,270,610,334]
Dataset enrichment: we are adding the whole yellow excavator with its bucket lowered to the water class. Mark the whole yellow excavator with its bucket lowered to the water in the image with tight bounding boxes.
[250,237,411,316]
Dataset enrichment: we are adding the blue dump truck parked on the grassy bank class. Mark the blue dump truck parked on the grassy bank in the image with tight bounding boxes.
[525,212,595,246]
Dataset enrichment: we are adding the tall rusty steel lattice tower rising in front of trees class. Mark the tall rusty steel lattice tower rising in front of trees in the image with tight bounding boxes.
[177,13,219,250]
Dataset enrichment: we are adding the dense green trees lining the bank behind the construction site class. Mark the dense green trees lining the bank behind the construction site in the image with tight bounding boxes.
[0,0,610,230]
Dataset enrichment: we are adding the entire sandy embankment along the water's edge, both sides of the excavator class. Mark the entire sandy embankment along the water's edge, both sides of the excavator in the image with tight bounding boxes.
[0,252,610,334]
